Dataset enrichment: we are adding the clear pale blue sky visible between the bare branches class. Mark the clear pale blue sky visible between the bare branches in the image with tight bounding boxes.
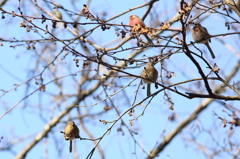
[0,0,240,159]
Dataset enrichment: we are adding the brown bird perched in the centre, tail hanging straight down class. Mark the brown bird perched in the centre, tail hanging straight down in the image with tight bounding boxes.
[141,62,158,96]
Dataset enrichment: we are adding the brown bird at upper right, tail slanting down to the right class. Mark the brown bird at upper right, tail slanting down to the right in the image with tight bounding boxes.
[192,24,215,59]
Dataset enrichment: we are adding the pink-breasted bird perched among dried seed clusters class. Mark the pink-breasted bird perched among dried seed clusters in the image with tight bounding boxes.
[128,15,154,45]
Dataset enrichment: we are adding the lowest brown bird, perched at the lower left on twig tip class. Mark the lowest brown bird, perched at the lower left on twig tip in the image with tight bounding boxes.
[63,121,80,153]
